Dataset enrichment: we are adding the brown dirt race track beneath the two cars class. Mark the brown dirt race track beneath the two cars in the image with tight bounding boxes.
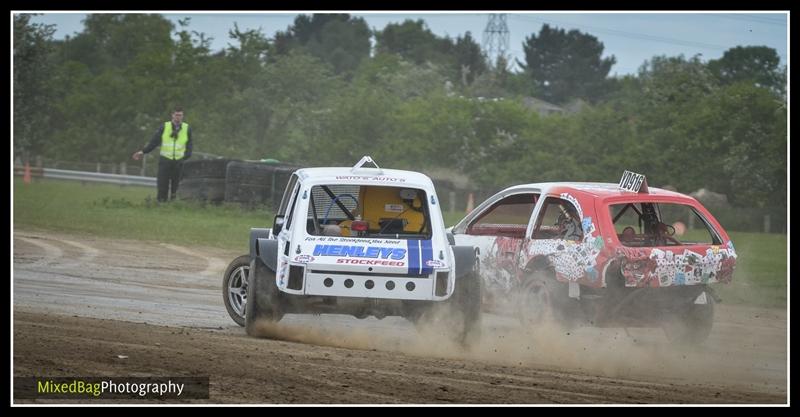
[13,230,787,404]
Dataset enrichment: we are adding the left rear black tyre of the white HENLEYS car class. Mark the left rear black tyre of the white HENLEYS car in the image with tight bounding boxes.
[244,258,283,336]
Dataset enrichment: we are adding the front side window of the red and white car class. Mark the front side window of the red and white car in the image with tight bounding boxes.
[467,193,539,238]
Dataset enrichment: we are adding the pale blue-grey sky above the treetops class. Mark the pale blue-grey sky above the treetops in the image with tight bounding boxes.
[25,11,788,75]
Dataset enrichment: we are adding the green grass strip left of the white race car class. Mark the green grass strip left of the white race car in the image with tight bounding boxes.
[14,179,272,252]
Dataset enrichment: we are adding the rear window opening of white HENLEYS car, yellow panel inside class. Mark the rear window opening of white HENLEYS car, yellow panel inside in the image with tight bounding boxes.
[307,185,431,239]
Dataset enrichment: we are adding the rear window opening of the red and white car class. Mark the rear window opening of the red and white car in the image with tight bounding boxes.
[609,202,722,247]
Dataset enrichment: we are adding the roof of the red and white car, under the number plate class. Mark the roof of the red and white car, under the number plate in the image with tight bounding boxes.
[504,182,695,202]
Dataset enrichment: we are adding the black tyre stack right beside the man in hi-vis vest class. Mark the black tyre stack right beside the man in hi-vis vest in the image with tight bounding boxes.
[178,158,232,203]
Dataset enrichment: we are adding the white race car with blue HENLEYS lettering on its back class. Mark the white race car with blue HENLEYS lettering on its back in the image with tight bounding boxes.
[223,156,481,345]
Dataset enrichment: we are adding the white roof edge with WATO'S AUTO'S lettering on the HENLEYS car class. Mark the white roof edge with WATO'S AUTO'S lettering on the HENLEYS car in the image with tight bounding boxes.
[295,167,433,189]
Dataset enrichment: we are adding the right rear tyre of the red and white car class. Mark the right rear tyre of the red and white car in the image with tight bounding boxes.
[662,292,714,346]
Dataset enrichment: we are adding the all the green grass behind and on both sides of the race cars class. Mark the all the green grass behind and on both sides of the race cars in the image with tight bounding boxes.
[13,179,787,307]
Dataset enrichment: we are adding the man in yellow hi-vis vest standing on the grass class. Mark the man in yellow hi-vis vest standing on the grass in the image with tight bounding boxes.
[133,107,192,201]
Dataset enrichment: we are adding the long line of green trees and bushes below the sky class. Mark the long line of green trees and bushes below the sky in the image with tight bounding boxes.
[13,14,787,207]
